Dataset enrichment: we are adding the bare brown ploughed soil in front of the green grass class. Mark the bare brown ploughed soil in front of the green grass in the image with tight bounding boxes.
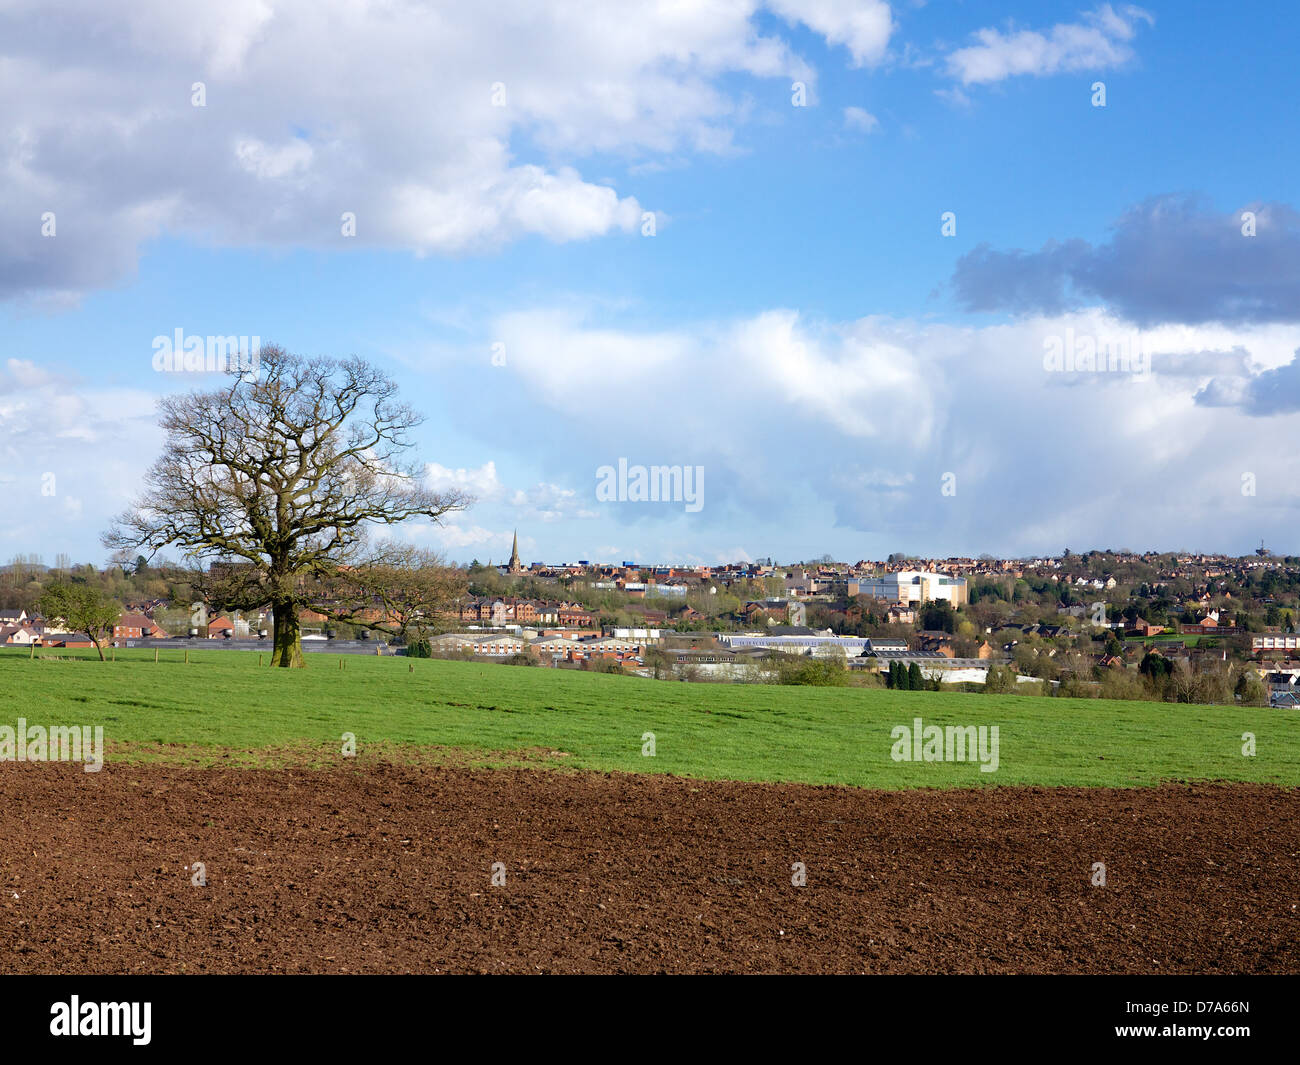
[0,763,1300,973]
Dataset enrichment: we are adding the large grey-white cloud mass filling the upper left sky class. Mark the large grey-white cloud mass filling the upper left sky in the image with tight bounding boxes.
[0,0,832,299]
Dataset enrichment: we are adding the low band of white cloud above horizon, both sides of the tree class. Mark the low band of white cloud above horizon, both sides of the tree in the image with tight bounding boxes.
[10,300,1300,560]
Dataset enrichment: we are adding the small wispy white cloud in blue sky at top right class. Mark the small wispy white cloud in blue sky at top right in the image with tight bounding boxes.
[946,4,1154,85]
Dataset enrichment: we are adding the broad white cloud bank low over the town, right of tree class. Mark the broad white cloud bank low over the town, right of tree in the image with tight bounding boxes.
[470,300,1300,558]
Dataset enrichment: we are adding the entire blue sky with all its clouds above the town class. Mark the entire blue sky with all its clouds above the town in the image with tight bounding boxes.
[0,0,1300,564]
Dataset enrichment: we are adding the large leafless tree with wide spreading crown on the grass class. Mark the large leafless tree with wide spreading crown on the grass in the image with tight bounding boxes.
[103,347,473,668]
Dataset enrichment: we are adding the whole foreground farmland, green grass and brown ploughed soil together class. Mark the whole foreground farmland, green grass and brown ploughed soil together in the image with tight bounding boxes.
[0,650,1300,973]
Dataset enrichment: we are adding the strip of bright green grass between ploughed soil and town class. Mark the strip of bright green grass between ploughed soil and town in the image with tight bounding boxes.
[0,649,1300,788]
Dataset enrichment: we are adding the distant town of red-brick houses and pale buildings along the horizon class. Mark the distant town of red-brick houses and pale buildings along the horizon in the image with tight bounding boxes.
[0,537,1300,706]
